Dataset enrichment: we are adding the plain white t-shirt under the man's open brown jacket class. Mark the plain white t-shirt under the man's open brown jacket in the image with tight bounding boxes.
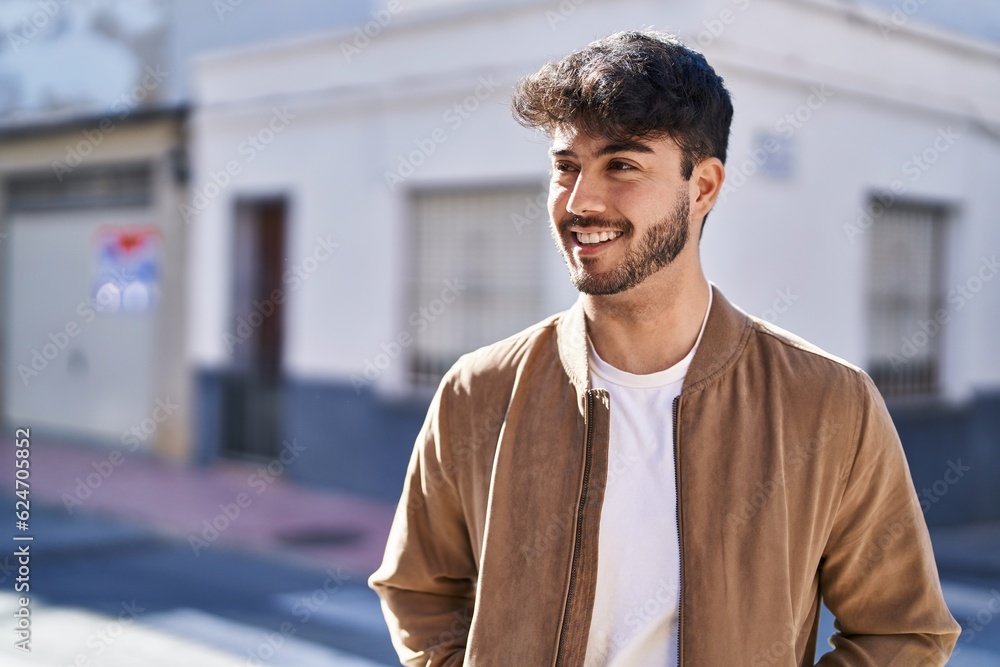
[584,289,712,667]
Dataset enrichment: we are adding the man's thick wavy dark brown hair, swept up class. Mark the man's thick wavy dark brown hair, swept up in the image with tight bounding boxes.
[513,31,733,179]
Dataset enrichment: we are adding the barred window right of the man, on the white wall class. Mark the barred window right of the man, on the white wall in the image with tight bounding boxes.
[868,202,946,398]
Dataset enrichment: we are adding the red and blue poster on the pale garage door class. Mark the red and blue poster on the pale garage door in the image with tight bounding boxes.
[90,225,162,315]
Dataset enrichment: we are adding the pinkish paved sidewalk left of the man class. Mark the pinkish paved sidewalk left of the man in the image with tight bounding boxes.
[0,440,394,577]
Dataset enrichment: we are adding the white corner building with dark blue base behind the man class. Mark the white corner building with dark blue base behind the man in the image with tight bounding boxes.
[186,0,1000,523]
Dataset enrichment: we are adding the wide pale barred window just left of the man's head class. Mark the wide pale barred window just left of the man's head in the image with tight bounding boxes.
[406,187,551,387]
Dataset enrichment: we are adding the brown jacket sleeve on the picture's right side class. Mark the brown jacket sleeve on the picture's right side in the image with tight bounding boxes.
[818,373,961,667]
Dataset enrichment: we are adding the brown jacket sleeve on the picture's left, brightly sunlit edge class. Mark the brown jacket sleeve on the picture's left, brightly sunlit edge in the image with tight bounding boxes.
[368,376,477,667]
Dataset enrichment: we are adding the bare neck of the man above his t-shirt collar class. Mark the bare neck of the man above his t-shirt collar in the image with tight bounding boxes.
[583,257,709,375]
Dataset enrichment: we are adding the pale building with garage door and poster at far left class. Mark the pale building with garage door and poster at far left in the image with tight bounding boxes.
[0,0,366,460]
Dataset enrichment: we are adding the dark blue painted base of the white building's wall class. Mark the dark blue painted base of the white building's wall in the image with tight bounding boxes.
[196,371,1000,526]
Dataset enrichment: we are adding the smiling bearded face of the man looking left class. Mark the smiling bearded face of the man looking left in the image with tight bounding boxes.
[549,130,690,295]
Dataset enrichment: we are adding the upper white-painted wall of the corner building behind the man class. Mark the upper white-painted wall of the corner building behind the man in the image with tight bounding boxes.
[190,0,1000,396]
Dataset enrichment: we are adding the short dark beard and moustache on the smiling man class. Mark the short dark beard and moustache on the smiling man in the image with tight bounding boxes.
[552,191,690,296]
